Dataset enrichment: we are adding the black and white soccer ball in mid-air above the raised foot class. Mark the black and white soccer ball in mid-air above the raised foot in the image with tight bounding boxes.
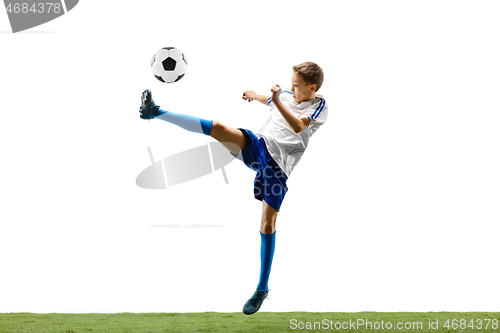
[151,47,187,83]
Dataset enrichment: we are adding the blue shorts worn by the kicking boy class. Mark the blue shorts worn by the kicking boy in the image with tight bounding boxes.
[233,128,288,211]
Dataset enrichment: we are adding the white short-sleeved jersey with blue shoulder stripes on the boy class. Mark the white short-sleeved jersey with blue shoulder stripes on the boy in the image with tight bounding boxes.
[257,90,328,177]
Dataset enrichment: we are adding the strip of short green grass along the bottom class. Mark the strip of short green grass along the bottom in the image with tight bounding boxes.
[0,312,500,333]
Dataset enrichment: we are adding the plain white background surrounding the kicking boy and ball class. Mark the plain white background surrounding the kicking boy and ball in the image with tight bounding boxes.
[0,0,500,312]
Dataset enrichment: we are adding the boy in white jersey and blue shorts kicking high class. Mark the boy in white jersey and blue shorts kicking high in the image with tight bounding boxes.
[140,62,328,315]
